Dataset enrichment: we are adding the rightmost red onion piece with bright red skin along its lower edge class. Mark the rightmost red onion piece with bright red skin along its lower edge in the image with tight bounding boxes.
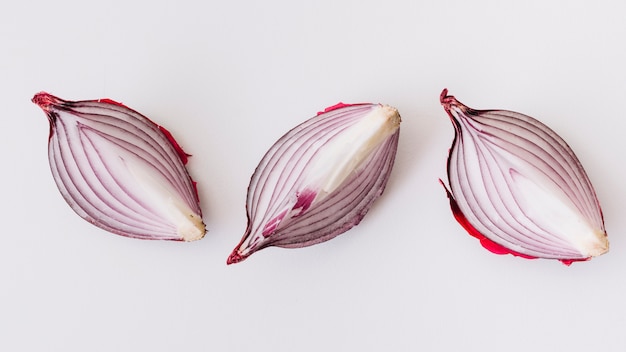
[441,89,609,265]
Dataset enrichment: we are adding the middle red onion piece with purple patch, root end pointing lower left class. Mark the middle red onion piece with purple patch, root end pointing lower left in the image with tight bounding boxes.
[227,104,400,264]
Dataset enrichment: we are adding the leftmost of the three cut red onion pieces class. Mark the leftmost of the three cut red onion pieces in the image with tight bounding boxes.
[32,92,205,241]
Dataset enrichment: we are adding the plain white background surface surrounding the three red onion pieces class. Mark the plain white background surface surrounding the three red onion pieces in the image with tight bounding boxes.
[0,0,626,352]
